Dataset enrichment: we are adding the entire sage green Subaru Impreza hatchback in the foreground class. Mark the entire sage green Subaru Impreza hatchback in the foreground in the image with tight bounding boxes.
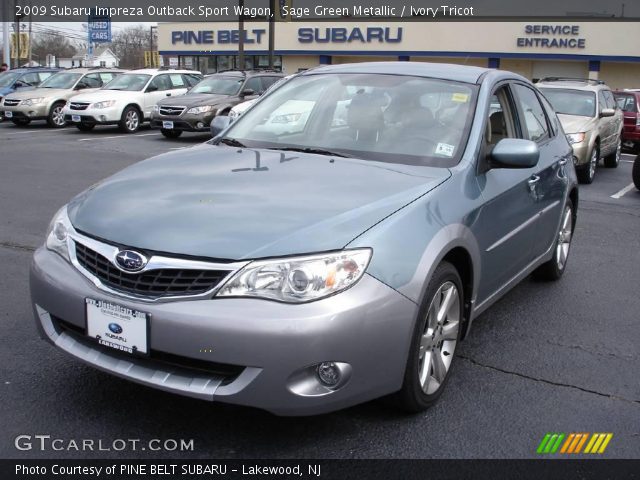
[30,62,578,415]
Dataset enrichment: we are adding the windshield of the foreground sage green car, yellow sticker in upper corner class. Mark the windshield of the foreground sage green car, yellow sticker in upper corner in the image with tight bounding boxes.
[222,74,476,167]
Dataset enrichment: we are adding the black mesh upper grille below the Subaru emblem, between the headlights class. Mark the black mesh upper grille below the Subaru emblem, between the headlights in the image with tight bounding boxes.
[76,242,229,298]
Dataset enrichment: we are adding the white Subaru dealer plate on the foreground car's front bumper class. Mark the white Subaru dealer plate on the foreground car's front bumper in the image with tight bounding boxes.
[86,298,149,354]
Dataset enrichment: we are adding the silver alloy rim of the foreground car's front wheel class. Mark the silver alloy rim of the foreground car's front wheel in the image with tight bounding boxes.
[418,282,461,395]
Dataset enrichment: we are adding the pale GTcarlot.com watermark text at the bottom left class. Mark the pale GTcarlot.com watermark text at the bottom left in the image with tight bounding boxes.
[13,435,195,452]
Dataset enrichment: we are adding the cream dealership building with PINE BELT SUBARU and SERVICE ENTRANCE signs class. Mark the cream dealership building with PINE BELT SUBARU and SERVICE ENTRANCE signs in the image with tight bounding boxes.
[158,19,640,88]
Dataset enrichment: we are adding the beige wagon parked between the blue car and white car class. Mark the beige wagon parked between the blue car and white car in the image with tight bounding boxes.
[2,68,122,128]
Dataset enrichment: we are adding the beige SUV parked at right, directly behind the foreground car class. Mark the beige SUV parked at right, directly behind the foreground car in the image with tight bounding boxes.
[536,77,623,183]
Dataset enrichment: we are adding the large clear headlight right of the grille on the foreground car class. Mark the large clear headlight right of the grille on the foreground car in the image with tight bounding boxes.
[216,248,372,303]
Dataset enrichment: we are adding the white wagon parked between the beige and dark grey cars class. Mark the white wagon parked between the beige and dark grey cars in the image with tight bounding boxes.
[63,68,202,133]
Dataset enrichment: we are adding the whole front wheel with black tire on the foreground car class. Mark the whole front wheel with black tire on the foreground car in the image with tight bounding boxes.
[392,262,464,413]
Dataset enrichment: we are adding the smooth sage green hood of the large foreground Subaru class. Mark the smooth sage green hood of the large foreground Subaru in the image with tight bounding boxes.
[68,144,451,260]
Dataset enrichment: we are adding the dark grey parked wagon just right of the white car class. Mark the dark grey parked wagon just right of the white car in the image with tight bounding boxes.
[151,70,282,138]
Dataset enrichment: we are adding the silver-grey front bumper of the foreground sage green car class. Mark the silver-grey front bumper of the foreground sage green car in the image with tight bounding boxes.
[30,248,417,415]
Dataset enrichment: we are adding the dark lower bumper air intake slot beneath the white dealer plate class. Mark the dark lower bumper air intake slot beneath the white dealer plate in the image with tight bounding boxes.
[51,315,245,385]
